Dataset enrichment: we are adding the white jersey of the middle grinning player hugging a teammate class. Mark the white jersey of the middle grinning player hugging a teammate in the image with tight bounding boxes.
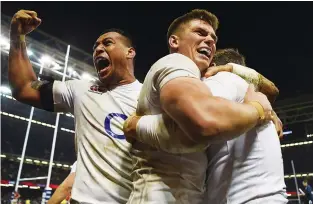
[129,53,207,204]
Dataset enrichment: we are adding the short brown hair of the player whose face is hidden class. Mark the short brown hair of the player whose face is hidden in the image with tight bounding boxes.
[212,48,246,66]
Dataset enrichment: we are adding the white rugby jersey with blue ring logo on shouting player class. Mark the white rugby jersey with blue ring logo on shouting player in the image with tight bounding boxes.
[53,80,141,204]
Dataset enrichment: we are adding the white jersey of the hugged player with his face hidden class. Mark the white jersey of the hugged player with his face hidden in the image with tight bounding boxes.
[203,72,288,204]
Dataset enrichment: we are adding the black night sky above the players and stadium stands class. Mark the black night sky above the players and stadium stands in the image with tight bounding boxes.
[1,2,313,99]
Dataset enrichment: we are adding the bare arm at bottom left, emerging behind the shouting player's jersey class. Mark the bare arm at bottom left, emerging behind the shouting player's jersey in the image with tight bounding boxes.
[48,172,75,204]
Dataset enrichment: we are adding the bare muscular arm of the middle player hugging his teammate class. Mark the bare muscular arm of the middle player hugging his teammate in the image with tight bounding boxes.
[160,77,259,141]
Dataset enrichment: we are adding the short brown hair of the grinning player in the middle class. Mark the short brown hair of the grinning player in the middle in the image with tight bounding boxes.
[167,9,219,39]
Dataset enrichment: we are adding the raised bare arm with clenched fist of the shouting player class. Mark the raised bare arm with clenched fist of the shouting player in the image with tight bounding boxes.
[8,10,45,108]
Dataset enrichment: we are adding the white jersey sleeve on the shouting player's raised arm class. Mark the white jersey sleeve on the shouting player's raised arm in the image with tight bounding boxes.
[53,80,77,113]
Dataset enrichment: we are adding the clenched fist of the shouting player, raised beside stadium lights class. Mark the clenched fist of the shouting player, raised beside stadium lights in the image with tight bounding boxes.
[10,10,41,38]
